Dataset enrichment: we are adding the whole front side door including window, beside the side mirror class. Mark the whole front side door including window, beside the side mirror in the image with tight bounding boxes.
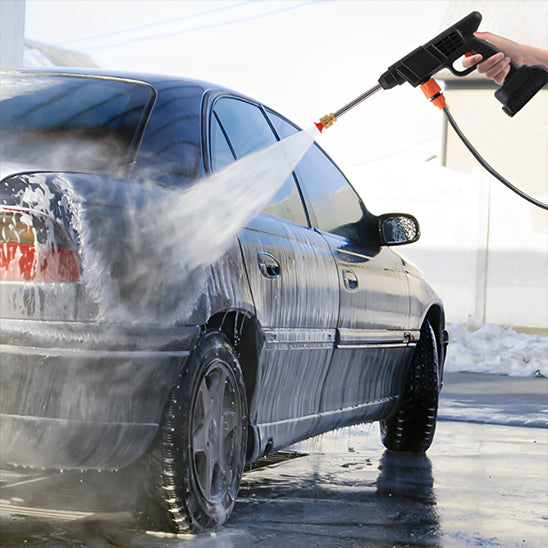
[295,141,411,427]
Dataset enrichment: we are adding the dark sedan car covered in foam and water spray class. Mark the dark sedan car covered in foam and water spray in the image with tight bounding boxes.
[0,70,447,531]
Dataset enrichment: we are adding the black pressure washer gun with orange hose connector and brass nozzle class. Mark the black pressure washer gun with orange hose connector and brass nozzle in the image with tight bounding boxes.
[315,11,548,131]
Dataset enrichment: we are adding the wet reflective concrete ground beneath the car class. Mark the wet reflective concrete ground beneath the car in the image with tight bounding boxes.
[0,374,548,548]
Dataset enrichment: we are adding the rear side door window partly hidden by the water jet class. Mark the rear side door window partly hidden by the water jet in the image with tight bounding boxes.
[210,97,308,226]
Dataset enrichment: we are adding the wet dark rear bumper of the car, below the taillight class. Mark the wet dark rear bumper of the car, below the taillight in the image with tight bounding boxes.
[0,320,199,469]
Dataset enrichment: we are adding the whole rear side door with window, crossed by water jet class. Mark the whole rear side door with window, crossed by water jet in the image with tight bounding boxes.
[210,95,339,451]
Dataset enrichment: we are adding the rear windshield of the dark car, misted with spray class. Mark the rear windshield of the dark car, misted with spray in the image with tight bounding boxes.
[0,74,154,174]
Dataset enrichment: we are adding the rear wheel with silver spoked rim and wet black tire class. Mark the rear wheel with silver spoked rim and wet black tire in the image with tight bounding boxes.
[134,332,247,533]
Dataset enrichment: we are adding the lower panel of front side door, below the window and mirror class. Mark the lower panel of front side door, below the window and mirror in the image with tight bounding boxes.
[322,231,413,416]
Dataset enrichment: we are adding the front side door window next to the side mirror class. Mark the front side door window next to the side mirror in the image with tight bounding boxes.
[295,144,366,241]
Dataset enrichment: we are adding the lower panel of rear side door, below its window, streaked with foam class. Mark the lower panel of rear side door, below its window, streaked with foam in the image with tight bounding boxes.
[239,215,339,454]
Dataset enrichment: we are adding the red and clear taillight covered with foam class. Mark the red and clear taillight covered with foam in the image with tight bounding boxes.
[0,209,81,282]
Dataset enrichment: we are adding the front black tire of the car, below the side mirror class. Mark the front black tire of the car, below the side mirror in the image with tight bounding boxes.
[380,320,440,453]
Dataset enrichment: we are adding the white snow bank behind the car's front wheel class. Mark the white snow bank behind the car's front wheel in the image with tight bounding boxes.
[445,317,548,377]
